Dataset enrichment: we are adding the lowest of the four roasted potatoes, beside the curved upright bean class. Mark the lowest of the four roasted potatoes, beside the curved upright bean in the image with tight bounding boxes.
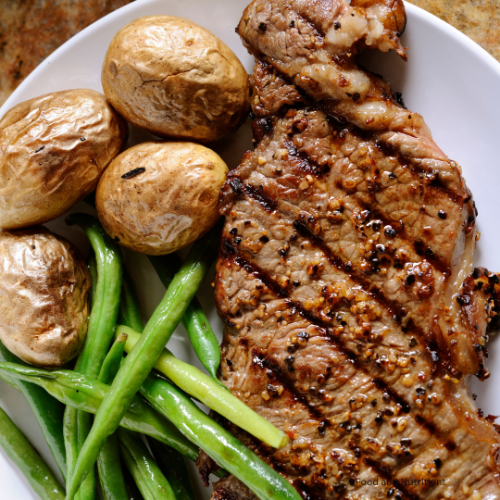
[0,226,90,368]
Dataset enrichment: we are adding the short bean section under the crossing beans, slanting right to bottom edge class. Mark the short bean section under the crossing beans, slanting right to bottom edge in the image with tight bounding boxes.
[118,429,176,500]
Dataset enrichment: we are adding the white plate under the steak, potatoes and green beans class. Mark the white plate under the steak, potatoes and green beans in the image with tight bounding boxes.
[0,0,500,500]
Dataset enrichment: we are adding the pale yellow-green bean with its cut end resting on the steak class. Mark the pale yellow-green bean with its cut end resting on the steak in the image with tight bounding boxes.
[117,325,288,448]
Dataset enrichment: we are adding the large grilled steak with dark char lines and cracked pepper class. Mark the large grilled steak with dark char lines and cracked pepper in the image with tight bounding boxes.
[209,0,500,500]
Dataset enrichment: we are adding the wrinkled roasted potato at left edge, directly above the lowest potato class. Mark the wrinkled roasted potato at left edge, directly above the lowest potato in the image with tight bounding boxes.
[0,90,128,229]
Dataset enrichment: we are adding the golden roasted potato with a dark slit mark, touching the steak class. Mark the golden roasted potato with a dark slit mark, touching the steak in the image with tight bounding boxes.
[96,142,227,255]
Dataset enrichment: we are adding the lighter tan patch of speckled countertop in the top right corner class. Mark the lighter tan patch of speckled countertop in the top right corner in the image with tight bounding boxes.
[409,0,500,61]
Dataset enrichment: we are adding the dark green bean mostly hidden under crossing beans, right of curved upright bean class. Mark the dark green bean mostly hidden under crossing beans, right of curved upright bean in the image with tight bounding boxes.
[97,334,127,500]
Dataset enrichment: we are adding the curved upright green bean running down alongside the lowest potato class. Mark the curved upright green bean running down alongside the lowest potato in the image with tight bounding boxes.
[64,214,122,500]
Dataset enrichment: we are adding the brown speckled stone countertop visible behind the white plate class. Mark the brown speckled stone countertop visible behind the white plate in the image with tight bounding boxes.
[0,0,500,105]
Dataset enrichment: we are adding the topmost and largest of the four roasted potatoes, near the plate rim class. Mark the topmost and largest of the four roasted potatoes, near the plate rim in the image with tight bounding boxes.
[101,16,249,143]
